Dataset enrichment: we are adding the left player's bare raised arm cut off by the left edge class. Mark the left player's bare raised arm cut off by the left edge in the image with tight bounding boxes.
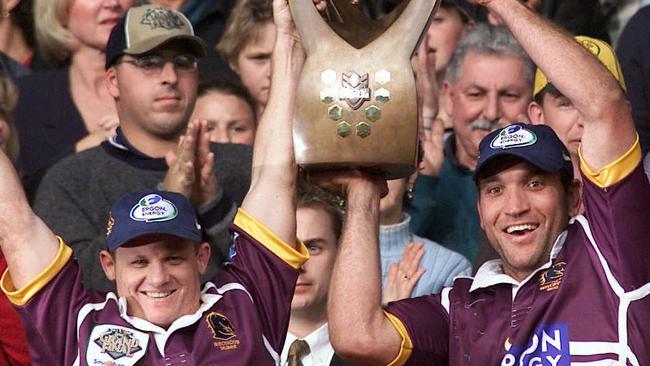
[0,151,59,290]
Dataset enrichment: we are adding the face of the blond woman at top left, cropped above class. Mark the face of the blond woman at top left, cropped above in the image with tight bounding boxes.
[66,0,135,51]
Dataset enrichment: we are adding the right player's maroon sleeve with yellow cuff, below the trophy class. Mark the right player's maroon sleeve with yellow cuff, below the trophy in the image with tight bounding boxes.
[385,295,449,366]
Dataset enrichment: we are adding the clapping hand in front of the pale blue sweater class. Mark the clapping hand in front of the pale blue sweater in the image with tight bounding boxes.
[381,243,426,305]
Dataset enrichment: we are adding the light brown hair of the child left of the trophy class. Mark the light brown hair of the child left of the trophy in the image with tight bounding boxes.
[217,0,273,64]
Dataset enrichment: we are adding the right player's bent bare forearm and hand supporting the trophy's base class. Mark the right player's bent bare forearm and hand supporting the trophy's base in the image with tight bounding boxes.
[327,172,402,365]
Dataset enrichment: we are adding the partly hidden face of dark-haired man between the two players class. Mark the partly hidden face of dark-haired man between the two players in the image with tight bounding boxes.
[291,207,337,316]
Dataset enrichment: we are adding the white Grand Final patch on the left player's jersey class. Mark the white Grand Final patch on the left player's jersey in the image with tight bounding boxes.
[86,324,149,366]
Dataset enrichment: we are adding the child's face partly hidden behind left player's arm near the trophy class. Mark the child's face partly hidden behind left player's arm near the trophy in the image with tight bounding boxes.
[230,21,275,109]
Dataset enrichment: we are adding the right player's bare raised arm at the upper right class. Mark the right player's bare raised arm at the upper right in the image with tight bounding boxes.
[480,0,636,171]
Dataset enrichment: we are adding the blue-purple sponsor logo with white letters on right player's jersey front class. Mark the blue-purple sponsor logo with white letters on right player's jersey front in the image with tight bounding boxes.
[501,323,571,366]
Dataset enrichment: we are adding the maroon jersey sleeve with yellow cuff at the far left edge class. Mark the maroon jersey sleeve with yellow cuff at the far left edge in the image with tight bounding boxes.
[0,238,98,365]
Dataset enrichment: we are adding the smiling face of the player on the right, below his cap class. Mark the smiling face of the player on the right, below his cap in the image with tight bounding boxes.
[478,158,580,281]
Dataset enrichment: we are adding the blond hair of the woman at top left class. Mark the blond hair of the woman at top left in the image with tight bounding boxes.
[34,0,74,64]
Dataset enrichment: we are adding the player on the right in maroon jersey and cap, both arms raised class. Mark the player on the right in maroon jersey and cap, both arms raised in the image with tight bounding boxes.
[328,0,650,366]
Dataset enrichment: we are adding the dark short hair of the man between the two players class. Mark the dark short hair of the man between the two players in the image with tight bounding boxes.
[296,178,343,246]
